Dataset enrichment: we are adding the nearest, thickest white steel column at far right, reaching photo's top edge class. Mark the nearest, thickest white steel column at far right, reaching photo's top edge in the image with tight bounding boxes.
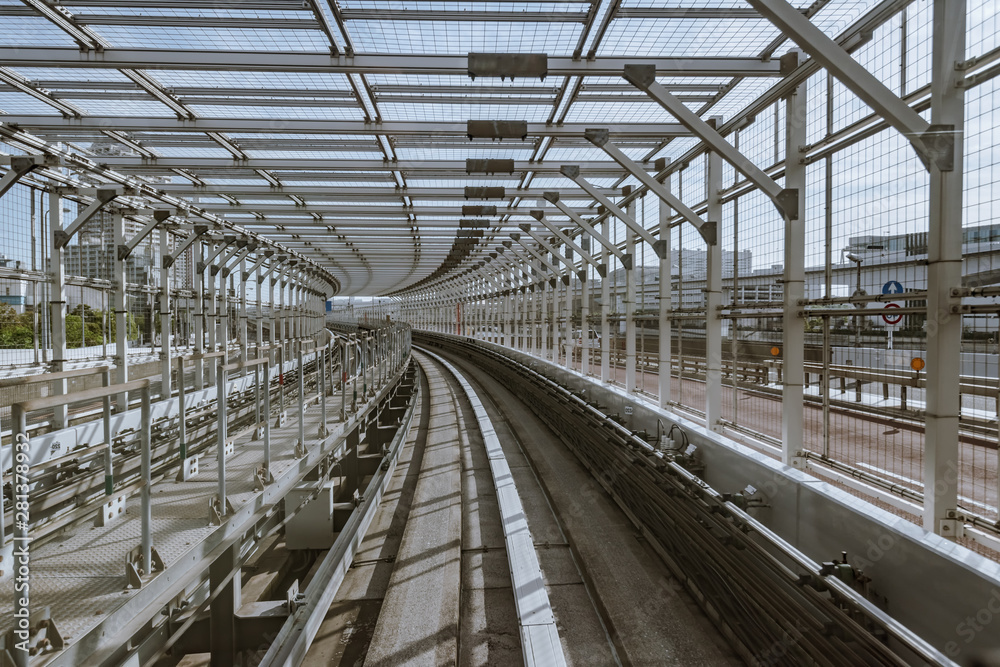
[924,0,966,539]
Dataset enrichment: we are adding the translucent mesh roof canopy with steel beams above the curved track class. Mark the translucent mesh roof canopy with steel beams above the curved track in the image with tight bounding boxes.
[0,0,984,300]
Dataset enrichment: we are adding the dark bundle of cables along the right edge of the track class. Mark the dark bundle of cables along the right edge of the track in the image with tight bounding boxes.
[418,336,947,666]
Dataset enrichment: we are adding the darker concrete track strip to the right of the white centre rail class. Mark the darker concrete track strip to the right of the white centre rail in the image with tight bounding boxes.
[441,350,741,665]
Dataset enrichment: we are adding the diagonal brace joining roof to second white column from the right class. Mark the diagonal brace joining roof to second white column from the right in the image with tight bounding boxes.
[623,65,799,220]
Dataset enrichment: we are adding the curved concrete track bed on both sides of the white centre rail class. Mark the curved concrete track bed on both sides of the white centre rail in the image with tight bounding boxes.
[303,352,739,665]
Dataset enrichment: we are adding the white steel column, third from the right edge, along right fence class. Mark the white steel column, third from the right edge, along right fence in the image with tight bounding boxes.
[705,151,722,431]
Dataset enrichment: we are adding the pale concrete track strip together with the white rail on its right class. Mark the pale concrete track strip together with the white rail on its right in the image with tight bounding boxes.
[303,353,565,665]
